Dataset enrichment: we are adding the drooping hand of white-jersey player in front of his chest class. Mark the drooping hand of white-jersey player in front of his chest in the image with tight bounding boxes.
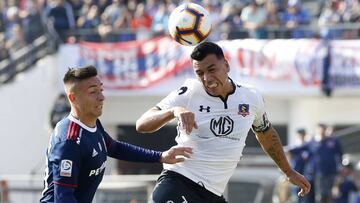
[173,106,198,134]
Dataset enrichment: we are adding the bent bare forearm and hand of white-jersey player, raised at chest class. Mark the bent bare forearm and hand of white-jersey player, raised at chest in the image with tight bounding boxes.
[136,106,198,134]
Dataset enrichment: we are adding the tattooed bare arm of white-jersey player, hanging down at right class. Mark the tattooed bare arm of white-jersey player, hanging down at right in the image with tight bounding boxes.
[254,126,310,196]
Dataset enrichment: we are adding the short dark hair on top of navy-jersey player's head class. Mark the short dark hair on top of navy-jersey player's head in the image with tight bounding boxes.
[63,65,97,84]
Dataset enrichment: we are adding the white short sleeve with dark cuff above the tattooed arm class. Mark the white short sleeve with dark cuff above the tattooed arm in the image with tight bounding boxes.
[252,95,271,132]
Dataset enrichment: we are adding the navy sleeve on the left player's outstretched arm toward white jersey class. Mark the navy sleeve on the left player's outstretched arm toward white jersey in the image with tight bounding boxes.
[104,133,161,162]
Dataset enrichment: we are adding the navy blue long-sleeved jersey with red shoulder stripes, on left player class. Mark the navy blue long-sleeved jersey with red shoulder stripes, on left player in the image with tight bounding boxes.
[40,115,161,203]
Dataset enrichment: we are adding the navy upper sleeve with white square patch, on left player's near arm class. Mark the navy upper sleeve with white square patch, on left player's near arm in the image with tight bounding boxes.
[51,140,81,187]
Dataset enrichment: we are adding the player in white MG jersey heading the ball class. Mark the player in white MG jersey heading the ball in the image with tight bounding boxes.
[136,42,310,203]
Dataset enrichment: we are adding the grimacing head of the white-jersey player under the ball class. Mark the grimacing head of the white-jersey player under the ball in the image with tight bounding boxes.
[191,42,232,97]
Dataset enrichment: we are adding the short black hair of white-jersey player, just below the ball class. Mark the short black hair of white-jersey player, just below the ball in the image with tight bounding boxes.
[191,42,225,61]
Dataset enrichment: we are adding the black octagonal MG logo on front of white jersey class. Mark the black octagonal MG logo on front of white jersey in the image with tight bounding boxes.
[210,116,234,137]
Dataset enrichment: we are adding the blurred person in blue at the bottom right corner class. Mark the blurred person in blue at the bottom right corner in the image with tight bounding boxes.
[332,163,358,203]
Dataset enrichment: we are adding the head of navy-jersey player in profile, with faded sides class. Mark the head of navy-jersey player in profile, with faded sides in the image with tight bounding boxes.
[63,66,105,118]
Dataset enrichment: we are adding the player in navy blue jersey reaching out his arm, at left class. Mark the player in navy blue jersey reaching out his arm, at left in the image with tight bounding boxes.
[40,66,192,203]
